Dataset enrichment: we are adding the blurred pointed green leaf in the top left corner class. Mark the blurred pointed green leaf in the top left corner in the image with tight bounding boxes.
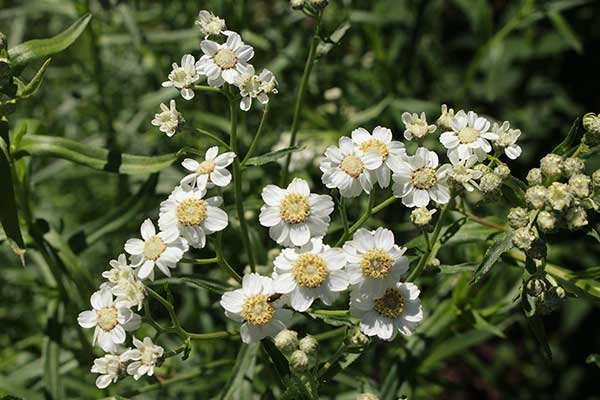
[8,14,92,68]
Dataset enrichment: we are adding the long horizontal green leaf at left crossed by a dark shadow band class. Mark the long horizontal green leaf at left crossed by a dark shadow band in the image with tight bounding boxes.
[13,135,193,174]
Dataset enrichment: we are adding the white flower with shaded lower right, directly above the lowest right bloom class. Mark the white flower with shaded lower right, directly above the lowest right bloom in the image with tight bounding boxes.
[344,228,408,297]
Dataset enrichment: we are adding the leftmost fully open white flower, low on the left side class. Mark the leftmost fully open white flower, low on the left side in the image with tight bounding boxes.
[77,286,141,353]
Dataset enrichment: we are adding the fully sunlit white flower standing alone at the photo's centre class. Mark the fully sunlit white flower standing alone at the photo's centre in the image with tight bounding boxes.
[259,178,333,246]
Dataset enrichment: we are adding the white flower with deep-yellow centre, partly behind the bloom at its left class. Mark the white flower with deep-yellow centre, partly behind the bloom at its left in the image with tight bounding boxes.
[352,126,406,188]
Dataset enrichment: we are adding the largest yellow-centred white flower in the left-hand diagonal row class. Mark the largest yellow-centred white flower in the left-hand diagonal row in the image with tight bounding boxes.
[158,186,229,249]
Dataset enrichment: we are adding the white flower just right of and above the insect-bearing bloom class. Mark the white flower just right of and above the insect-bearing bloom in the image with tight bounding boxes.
[273,238,348,311]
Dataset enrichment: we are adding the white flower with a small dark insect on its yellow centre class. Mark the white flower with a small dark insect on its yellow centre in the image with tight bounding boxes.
[221,273,292,343]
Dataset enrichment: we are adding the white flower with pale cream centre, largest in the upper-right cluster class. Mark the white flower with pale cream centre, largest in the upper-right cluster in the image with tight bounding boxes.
[440,110,498,161]
